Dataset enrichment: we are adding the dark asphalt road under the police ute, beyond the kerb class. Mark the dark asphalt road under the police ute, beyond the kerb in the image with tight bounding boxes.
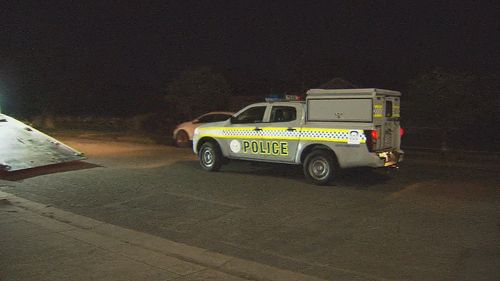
[0,138,500,280]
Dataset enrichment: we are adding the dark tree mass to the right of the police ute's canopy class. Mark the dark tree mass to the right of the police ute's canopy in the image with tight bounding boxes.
[402,69,500,150]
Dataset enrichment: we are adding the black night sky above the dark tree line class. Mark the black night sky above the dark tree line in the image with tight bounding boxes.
[0,1,500,114]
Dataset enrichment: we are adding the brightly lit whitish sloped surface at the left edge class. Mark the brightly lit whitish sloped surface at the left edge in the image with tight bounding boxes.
[0,114,85,171]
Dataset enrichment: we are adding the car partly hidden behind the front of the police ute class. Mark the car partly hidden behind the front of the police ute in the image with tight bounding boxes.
[173,111,234,147]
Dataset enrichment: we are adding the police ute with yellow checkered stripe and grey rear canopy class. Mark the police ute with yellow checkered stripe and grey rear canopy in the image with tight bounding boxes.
[193,89,403,185]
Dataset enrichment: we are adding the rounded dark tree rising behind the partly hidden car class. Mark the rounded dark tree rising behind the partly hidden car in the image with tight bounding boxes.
[165,67,231,119]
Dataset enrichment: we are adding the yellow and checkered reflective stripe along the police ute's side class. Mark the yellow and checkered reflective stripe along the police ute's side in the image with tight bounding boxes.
[200,128,366,143]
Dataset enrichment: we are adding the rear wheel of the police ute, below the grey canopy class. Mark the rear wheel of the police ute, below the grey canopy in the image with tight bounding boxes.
[304,149,337,185]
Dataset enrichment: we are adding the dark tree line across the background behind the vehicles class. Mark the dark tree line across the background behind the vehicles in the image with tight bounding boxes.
[0,67,500,150]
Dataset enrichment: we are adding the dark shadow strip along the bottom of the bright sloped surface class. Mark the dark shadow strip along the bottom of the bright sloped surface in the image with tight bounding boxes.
[0,161,102,181]
